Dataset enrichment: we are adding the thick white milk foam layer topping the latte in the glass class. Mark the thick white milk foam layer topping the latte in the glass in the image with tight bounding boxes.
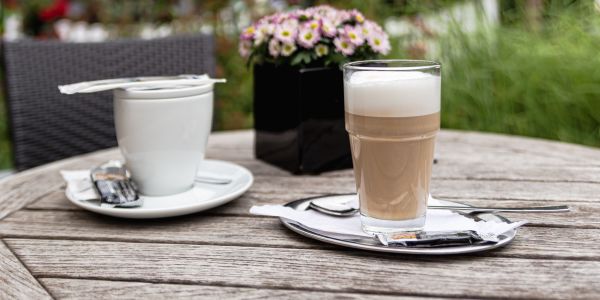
[344,71,441,117]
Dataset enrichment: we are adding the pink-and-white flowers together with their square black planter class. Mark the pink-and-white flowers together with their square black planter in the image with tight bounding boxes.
[239,6,390,174]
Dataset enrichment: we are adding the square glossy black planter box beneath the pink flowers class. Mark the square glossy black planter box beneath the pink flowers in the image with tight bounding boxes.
[254,64,352,174]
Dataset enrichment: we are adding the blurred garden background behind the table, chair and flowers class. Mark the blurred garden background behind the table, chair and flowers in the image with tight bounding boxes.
[0,0,600,168]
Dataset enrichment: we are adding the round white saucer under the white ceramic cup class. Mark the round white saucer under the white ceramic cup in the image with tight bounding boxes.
[65,160,254,219]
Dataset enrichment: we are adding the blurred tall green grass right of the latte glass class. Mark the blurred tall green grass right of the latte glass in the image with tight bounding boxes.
[439,1,600,146]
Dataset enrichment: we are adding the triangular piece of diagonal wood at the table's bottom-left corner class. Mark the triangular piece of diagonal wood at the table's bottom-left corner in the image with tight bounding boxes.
[0,240,52,299]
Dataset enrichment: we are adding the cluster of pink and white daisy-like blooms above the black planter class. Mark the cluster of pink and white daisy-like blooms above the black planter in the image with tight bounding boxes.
[239,5,391,59]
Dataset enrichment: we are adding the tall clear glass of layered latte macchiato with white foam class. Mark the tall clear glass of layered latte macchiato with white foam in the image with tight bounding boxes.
[343,60,441,233]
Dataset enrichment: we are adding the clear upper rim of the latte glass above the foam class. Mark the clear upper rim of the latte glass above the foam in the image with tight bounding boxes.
[342,59,442,71]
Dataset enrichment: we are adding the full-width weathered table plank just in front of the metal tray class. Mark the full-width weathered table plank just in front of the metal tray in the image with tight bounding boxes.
[6,239,600,299]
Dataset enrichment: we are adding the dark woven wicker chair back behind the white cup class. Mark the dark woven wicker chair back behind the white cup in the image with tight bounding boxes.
[3,35,215,170]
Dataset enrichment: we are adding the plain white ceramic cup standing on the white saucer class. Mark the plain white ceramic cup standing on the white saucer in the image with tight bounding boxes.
[114,84,213,196]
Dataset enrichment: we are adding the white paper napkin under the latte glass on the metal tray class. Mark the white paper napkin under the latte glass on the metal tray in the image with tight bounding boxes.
[250,199,527,242]
